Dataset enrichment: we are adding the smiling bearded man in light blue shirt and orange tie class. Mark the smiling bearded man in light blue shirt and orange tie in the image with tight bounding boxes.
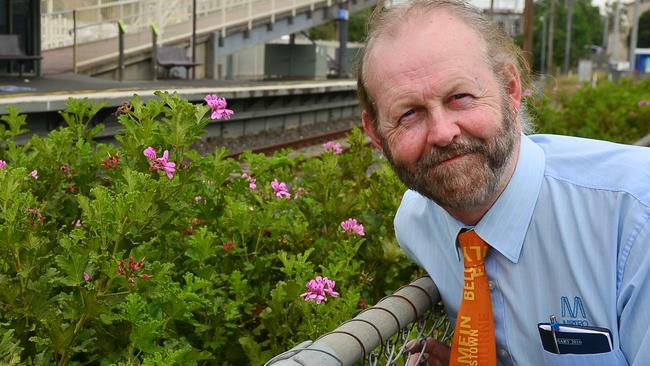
[358,0,650,366]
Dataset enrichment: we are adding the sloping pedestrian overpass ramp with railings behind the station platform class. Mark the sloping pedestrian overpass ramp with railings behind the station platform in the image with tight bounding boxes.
[41,0,378,78]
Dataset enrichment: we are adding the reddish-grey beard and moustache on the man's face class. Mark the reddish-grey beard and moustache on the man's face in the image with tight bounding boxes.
[381,101,519,210]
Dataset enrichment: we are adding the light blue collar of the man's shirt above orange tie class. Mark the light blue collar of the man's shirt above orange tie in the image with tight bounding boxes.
[434,135,546,263]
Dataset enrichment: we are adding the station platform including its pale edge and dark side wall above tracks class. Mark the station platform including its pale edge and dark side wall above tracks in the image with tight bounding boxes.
[0,74,359,142]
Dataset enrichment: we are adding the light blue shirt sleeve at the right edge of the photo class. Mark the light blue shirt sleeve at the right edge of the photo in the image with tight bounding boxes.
[617,215,650,366]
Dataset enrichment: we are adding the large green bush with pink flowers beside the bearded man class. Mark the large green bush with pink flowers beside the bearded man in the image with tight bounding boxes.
[0,93,414,365]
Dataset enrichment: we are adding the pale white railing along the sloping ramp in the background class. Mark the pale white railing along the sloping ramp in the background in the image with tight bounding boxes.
[41,0,333,50]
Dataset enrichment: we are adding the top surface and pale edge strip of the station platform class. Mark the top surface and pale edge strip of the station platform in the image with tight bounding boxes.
[0,73,356,114]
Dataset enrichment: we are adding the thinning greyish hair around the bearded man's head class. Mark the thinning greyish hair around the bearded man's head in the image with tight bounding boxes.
[357,0,532,136]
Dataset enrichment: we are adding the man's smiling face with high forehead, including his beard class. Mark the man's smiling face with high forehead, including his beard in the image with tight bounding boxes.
[364,11,519,210]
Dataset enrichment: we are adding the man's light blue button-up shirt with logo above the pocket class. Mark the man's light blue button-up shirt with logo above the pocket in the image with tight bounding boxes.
[395,135,650,366]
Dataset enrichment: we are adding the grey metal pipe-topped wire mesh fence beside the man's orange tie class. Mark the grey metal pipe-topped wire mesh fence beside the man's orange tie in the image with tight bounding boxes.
[265,277,452,366]
